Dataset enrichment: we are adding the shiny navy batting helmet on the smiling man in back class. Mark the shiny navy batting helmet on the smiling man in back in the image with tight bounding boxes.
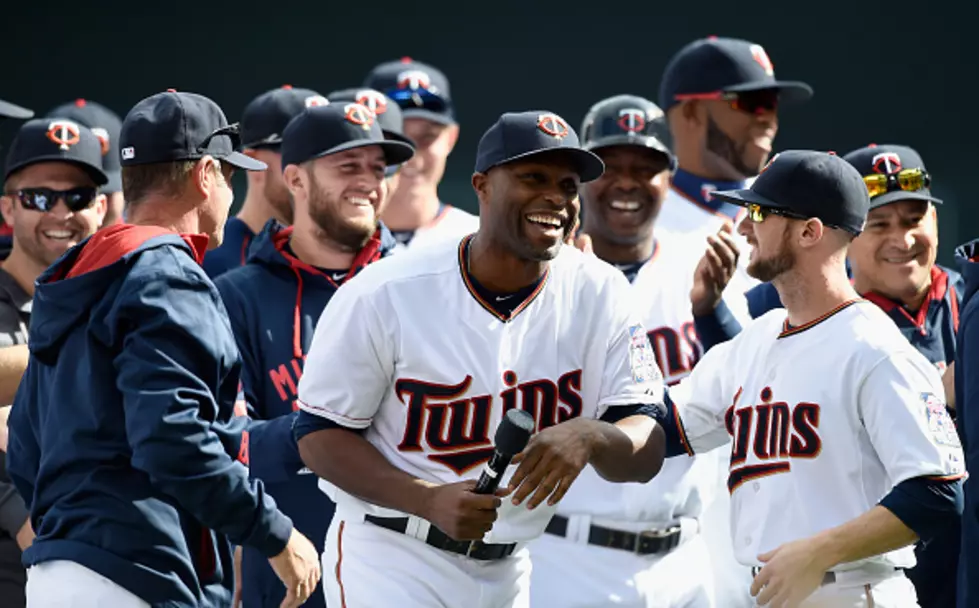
[581,95,676,169]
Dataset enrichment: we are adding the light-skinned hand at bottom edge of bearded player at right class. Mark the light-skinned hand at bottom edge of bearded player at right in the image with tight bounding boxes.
[751,539,832,608]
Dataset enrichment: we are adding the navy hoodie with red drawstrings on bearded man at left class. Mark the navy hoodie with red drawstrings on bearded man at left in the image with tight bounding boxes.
[215,220,397,608]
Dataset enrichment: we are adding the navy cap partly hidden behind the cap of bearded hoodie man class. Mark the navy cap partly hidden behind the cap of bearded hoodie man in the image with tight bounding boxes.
[241,84,329,148]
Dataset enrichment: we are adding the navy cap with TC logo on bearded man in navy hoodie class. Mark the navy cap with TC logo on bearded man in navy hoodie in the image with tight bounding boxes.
[282,102,415,169]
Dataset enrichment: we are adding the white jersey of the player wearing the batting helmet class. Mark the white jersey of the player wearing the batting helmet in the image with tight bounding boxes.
[558,230,751,527]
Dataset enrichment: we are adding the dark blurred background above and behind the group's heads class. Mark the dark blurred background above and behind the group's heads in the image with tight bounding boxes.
[0,0,979,264]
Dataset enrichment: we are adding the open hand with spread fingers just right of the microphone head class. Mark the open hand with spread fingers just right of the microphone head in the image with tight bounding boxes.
[508,418,599,509]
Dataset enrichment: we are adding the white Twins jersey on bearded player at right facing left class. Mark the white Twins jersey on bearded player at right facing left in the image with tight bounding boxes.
[670,299,964,571]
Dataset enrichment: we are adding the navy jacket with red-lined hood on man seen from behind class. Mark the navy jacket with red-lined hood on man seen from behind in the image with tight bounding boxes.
[7,225,292,607]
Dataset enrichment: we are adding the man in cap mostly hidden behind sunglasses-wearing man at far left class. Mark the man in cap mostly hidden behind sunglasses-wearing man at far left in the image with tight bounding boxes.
[48,99,125,227]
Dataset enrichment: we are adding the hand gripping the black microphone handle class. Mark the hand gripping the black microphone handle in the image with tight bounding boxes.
[422,480,504,541]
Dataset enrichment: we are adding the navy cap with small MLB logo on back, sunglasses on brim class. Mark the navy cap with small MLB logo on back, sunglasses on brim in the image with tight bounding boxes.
[119,89,268,171]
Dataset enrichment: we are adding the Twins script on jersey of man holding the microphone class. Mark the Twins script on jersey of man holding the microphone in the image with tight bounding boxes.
[394,368,580,475]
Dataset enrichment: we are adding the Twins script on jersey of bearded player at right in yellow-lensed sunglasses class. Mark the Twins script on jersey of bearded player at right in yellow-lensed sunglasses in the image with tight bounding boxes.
[724,386,823,493]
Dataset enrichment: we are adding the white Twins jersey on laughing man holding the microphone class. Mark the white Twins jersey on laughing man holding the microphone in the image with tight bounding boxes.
[299,237,663,543]
